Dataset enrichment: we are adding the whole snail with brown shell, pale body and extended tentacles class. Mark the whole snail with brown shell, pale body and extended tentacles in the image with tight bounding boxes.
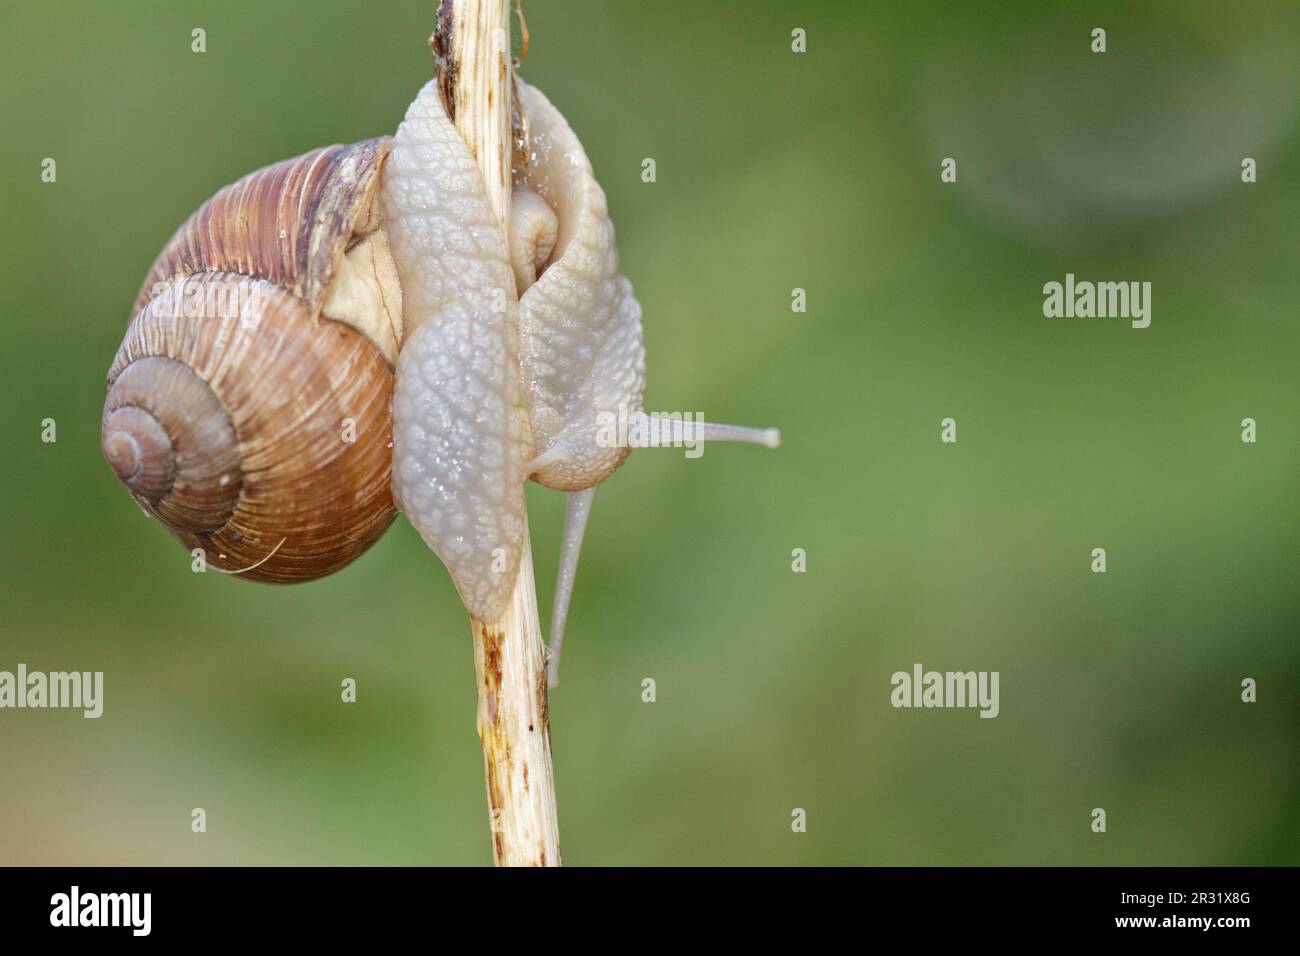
[101,74,780,679]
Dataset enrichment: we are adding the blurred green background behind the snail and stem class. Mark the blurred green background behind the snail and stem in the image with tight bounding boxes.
[0,0,1300,865]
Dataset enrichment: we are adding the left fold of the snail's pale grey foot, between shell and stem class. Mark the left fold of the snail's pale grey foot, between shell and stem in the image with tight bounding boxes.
[382,81,532,620]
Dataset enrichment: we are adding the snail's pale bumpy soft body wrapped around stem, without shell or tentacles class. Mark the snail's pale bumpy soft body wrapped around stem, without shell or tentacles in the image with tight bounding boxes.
[382,74,655,620]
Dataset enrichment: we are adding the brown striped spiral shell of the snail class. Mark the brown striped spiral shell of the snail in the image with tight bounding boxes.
[101,139,395,583]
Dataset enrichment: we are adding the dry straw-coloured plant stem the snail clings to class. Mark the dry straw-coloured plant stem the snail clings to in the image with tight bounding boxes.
[434,0,560,866]
